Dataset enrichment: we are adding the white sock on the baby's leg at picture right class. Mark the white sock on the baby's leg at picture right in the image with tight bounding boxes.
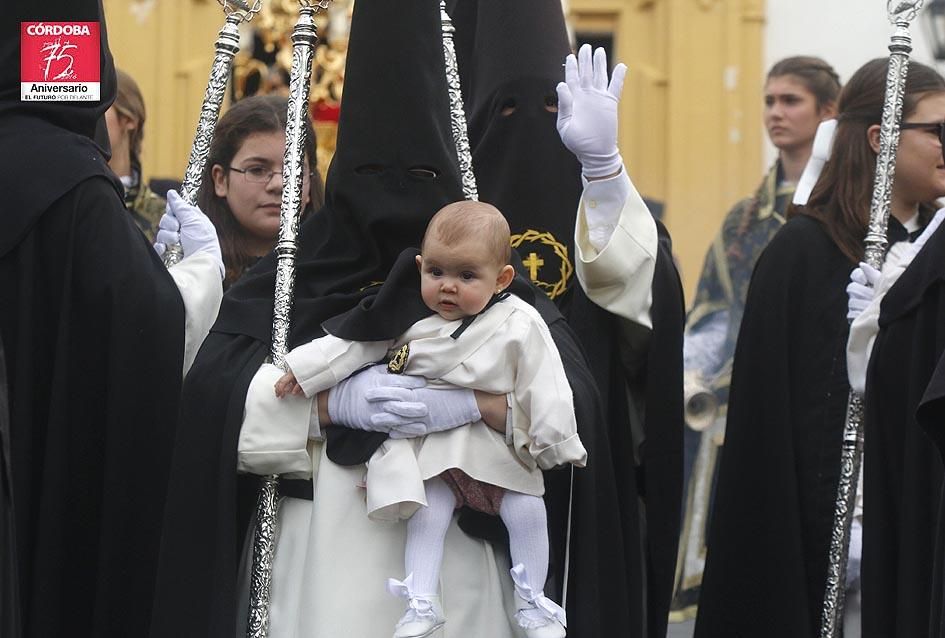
[499,492,548,594]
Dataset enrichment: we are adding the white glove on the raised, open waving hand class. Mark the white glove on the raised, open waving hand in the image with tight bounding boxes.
[558,44,627,177]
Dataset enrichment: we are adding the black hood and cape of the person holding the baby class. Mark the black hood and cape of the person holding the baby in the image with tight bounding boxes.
[151,2,600,638]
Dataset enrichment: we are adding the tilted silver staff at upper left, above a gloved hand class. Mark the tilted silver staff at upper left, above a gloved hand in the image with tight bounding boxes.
[164,0,262,268]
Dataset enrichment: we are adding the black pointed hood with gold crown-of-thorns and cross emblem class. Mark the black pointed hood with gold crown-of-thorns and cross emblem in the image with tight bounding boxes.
[447,0,582,300]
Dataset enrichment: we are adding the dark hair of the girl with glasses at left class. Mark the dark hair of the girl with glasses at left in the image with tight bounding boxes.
[197,95,325,288]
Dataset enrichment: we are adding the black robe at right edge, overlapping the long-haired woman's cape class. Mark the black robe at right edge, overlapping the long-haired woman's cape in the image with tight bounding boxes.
[861,218,945,638]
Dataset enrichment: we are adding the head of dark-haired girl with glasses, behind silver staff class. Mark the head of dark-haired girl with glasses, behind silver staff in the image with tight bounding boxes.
[197,95,324,288]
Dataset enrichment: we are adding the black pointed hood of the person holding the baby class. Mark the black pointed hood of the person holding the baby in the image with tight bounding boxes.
[215,0,463,345]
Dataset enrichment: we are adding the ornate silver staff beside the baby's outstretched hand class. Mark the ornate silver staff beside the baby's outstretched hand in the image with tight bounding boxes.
[246,0,331,638]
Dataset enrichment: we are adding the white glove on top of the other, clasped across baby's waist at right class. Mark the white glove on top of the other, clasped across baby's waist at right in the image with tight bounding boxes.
[360,377,482,439]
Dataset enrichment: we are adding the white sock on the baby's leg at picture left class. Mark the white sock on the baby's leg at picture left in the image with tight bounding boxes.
[404,478,456,596]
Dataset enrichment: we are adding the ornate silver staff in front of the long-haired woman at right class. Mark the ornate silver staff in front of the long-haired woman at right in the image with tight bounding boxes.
[820,0,923,638]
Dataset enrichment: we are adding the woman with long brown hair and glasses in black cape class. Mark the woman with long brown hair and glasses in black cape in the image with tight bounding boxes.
[696,59,945,637]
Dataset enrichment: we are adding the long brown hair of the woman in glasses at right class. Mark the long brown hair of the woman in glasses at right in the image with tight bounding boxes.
[788,58,945,263]
